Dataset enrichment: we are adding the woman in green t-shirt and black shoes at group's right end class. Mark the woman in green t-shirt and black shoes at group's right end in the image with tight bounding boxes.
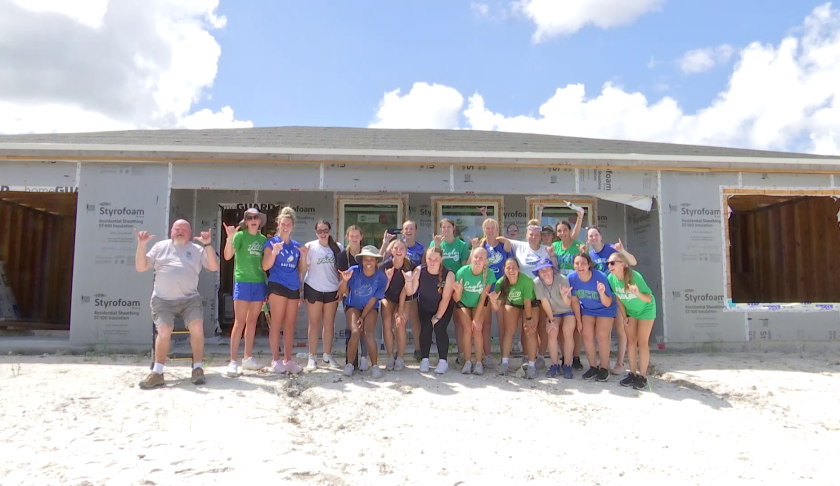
[607,253,656,390]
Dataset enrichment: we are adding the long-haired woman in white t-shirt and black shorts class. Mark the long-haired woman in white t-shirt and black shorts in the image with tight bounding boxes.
[303,220,343,371]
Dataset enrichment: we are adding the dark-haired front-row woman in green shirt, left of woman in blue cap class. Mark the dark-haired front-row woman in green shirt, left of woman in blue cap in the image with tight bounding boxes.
[490,256,537,378]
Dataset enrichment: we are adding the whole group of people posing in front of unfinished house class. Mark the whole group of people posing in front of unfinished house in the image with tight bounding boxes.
[136,207,656,389]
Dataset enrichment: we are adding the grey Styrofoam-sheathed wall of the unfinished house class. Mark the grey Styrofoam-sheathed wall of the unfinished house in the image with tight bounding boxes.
[8,162,840,350]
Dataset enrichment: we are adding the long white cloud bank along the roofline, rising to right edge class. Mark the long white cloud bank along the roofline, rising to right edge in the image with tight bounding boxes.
[370,4,840,154]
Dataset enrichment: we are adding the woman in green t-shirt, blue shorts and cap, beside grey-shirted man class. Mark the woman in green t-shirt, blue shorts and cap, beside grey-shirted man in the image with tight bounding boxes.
[223,208,267,376]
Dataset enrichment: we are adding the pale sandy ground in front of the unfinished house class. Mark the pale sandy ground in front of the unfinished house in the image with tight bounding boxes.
[0,352,840,486]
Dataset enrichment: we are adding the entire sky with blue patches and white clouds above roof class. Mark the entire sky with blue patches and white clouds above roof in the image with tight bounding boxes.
[0,0,840,154]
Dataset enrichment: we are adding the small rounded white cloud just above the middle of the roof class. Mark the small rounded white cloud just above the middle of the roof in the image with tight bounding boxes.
[370,83,464,128]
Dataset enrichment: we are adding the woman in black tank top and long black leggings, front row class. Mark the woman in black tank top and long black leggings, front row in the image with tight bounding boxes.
[405,247,455,374]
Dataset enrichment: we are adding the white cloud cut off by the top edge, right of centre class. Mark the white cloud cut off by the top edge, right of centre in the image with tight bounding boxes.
[512,0,667,42]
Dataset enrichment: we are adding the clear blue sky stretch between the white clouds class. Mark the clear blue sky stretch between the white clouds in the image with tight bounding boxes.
[198,0,819,127]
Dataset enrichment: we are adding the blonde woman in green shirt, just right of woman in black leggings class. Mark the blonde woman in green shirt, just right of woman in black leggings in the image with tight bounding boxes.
[452,248,493,375]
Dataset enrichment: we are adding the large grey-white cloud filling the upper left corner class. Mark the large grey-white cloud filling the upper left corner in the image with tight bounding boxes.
[0,0,251,133]
